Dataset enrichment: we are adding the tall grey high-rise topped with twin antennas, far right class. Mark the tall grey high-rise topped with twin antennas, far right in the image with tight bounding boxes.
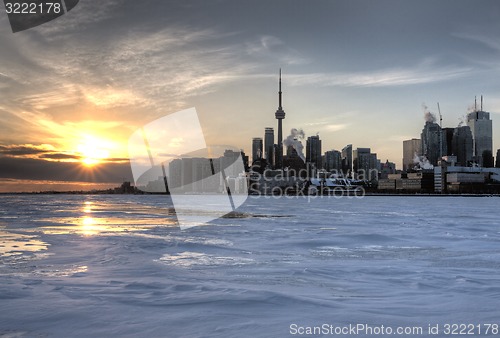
[467,96,493,166]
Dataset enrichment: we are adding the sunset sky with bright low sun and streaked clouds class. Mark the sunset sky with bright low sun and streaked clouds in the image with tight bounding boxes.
[0,0,500,192]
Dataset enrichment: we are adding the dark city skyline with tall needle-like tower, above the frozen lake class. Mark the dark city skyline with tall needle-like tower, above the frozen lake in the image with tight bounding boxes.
[254,74,500,175]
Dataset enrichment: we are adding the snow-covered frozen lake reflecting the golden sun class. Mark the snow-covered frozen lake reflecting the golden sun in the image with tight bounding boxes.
[0,195,500,337]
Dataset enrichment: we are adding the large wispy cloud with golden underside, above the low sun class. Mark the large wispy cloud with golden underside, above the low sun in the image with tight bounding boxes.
[0,25,262,120]
